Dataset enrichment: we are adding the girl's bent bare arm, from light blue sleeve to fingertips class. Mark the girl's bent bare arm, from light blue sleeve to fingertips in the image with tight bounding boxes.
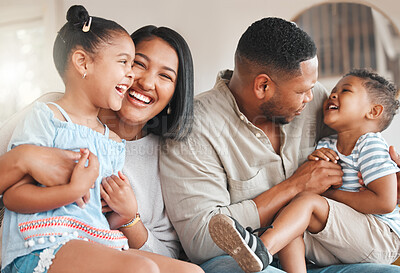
[3,147,99,213]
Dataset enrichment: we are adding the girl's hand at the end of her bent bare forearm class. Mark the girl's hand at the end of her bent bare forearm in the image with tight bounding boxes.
[70,149,99,198]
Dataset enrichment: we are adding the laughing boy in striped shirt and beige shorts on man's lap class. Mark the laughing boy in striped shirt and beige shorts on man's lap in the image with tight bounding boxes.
[209,69,400,272]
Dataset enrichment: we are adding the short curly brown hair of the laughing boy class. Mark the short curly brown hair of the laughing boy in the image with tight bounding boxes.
[343,68,400,131]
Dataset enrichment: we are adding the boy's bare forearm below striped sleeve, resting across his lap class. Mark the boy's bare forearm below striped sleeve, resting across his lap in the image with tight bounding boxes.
[323,174,397,214]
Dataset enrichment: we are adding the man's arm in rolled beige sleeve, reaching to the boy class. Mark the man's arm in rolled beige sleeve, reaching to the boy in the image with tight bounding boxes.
[160,132,342,263]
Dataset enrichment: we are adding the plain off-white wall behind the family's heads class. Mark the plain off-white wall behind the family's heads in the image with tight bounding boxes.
[0,0,400,147]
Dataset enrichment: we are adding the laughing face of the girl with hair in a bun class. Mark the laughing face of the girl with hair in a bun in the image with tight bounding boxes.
[86,34,135,111]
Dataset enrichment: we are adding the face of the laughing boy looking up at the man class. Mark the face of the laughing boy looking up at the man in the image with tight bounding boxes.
[323,76,372,133]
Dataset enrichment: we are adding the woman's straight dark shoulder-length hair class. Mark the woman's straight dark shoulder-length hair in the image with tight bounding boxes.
[131,25,194,140]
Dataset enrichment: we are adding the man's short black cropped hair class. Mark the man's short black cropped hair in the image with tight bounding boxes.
[236,17,317,76]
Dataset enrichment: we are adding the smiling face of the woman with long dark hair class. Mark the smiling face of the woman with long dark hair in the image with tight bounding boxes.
[118,37,179,125]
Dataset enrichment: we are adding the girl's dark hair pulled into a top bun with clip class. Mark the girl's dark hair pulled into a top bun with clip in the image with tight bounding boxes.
[53,5,129,78]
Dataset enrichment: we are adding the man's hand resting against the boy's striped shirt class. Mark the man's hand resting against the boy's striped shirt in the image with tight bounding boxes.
[290,160,343,194]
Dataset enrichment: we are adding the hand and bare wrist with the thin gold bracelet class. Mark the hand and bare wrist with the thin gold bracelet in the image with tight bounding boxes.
[100,172,148,249]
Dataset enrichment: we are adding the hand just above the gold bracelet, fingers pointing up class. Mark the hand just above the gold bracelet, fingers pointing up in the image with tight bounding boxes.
[100,172,138,224]
